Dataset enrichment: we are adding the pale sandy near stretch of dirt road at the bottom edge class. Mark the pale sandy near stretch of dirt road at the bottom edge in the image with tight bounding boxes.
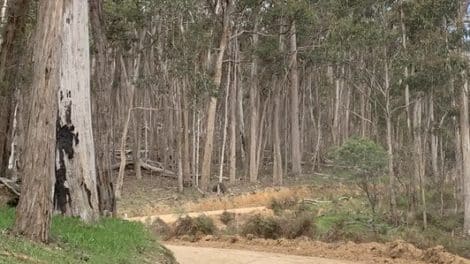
[165,245,359,264]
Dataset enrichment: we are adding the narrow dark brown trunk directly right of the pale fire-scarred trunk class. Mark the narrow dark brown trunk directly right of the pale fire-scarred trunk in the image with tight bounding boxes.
[90,0,116,215]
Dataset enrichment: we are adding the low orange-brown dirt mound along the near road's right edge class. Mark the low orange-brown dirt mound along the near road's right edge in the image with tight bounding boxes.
[168,236,470,264]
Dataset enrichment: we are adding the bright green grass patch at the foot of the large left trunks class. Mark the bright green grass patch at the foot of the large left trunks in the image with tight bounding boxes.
[0,209,173,264]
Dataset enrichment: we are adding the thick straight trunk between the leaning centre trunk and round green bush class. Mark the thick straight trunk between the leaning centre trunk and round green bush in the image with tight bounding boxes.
[289,22,302,176]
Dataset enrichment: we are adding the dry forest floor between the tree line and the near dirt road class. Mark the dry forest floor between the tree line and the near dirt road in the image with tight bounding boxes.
[118,171,470,264]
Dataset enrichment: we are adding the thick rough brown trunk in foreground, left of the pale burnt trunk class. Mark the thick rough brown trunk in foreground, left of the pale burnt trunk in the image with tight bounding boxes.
[15,0,63,242]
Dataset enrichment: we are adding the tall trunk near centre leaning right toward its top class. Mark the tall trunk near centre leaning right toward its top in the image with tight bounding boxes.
[199,0,232,190]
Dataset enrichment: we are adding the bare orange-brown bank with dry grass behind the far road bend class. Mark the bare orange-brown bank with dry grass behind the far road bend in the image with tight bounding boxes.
[118,171,360,218]
